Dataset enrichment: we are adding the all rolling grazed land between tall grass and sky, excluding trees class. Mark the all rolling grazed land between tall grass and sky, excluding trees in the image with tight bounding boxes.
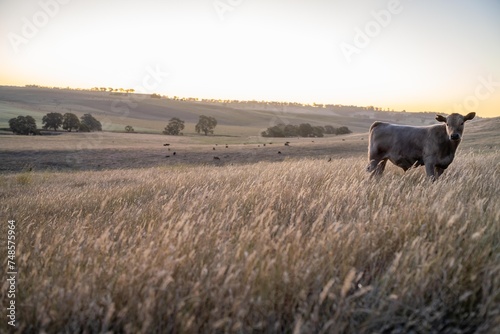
[0,87,500,171]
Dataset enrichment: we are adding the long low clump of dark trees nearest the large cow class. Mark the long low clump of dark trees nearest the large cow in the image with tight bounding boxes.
[261,123,352,137]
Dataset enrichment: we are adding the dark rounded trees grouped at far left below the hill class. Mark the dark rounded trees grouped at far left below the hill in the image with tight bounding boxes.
[9,112,102,135]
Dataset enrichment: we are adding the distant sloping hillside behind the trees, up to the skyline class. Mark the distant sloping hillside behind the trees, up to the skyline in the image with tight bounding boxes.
[0,87,446,136]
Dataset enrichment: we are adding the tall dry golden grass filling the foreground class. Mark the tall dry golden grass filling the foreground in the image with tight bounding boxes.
[0,153,500,333]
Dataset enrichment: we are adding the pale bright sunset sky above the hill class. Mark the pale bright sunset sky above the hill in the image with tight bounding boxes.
[0,0,500,117]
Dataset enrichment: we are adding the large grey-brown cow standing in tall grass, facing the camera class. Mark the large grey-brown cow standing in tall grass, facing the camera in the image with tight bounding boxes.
[366,112,476,180]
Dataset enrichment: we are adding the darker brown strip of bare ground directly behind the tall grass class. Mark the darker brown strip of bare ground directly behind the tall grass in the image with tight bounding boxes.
[0,138,367,172]
